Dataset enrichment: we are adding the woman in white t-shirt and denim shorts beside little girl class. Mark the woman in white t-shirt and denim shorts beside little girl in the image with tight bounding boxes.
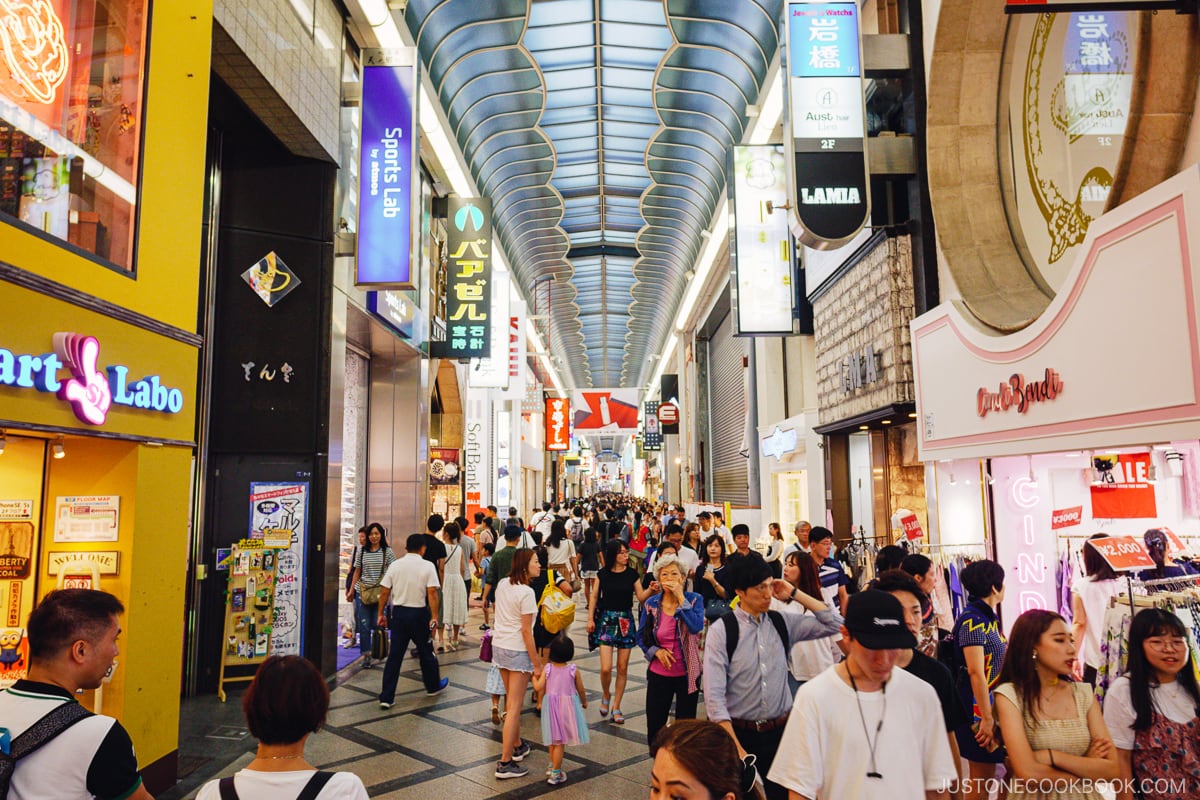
[492,548,541,780]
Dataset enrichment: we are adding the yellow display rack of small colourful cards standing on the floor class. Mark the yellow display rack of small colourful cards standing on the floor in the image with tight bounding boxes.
[217,539,279,703]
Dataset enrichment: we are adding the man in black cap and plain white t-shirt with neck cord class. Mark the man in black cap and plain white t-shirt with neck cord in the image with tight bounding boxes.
[769,590,958,800]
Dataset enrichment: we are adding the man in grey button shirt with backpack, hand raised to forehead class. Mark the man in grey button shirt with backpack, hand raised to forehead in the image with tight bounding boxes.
[704,553,842,800]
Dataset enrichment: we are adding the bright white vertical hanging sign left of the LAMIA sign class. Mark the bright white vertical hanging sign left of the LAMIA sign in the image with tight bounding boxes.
[729,144,797,335]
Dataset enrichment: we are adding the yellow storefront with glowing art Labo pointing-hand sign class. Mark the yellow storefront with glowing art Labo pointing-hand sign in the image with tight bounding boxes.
[0,0,210,794]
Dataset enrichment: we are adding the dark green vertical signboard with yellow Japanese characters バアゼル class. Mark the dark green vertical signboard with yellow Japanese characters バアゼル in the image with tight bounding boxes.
[443,197,492,359]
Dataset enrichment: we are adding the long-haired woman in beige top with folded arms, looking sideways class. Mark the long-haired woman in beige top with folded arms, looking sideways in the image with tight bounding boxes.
[995,608,1121,800]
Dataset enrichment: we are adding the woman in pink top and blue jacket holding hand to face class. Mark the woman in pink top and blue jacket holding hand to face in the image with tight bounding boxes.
[638,553,704,748]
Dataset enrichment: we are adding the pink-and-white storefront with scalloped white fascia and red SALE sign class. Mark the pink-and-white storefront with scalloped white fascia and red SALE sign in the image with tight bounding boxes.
[912,167,1200,625]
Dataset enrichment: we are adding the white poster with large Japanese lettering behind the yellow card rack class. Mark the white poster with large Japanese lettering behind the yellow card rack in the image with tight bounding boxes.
[250,481,308,656]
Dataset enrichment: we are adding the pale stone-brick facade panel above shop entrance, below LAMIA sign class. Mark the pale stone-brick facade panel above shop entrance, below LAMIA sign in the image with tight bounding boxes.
[812,236,913,425]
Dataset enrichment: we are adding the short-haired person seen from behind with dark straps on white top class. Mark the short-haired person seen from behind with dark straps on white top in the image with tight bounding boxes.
[196,656,367,800]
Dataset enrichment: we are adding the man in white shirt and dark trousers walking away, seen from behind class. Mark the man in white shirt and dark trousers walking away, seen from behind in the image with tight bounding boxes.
[379,534,450,709]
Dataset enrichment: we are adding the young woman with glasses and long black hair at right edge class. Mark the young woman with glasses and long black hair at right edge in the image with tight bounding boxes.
[1104,608,1200,800]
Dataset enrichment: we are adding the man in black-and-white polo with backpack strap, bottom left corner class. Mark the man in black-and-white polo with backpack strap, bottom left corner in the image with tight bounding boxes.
[0,589,152,800]
